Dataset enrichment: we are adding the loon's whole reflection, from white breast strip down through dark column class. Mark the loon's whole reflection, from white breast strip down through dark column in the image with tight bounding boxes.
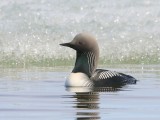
[66,87,119,120]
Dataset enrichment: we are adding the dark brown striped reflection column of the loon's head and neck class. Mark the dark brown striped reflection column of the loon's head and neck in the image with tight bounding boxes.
[74,92,100,120]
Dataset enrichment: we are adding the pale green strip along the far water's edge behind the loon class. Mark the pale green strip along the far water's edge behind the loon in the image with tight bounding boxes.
[0,55,160,68]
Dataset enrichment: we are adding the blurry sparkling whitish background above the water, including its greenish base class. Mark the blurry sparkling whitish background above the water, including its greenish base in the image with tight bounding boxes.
[0,0,160,67]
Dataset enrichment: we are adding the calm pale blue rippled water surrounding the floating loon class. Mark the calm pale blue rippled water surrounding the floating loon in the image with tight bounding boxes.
[0,65,160,120]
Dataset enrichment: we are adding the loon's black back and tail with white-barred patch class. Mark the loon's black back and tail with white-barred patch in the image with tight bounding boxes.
[90,69,137,87]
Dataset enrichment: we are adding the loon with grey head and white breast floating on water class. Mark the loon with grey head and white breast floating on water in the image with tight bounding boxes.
[60,33,137,87]
